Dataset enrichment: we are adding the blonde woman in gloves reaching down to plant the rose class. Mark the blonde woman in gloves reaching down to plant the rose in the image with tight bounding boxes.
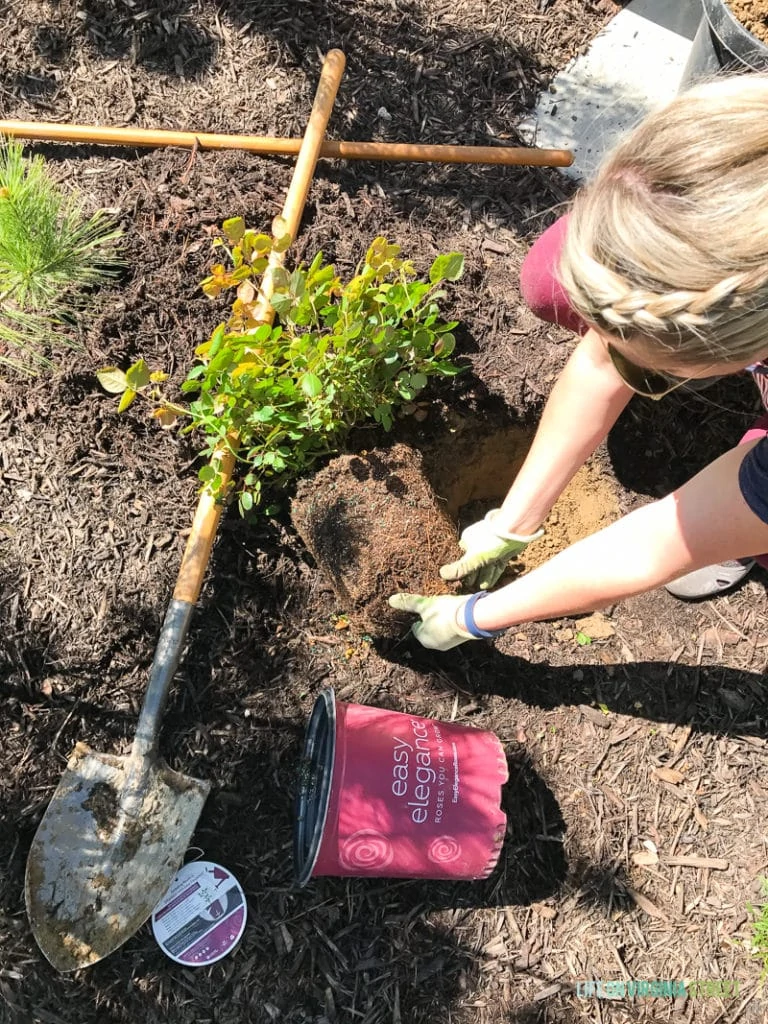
[389,75,768,650]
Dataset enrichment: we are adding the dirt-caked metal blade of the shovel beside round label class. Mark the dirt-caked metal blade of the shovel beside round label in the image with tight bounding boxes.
[26,743,210,971]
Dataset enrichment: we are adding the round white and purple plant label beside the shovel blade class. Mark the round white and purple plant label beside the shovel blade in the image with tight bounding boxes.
[152,860,247,967]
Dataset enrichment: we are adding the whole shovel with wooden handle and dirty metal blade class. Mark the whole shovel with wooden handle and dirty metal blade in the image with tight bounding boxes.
[26,50,345,971]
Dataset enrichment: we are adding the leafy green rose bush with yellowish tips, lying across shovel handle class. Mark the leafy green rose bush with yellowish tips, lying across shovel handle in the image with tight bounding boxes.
[99,218,464,514]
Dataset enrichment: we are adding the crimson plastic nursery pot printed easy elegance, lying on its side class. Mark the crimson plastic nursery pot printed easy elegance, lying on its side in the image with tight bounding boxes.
[294,689,509,886]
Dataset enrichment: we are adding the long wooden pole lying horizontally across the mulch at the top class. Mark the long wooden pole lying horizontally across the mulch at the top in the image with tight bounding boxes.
[0,121,573,167]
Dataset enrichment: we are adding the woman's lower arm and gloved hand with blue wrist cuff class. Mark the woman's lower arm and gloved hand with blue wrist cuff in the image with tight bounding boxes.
[389,441,768,650]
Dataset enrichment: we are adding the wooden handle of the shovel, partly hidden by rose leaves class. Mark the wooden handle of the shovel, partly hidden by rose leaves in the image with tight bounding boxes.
[173,50,346,604]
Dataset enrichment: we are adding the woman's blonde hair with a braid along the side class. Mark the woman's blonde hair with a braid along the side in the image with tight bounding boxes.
[559,75,768,368]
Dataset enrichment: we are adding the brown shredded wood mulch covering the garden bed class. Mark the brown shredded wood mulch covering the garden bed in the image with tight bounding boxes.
[0,0,768,1024]
